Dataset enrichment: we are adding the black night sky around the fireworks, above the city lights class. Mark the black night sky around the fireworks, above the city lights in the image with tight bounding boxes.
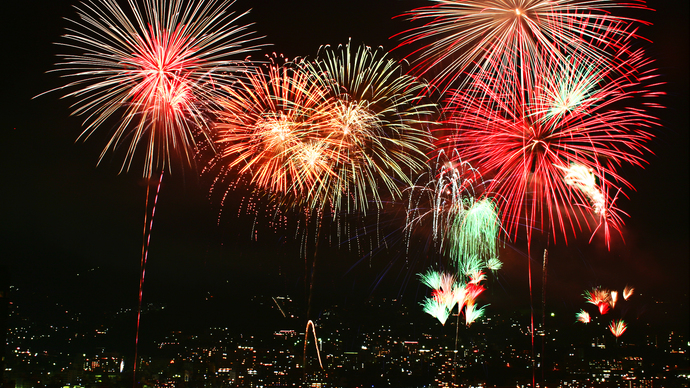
[0,0,690,338]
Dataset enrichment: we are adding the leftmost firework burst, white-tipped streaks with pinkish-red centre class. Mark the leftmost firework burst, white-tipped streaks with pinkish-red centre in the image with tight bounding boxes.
[45,0,258,177]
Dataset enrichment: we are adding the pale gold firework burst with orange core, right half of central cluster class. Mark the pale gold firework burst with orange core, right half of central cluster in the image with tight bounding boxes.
[301,43,437,212]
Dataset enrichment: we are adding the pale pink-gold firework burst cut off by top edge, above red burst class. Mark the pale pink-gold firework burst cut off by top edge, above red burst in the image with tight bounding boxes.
[399,0,646,90]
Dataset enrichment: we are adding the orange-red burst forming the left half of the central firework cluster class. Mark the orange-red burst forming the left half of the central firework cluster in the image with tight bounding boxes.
[212,58,332,202]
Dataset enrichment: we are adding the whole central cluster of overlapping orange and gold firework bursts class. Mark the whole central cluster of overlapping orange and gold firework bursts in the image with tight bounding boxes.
[214,44,434,218]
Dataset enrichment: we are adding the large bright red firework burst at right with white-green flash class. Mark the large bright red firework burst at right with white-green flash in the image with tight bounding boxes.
[439,47,659,243]
